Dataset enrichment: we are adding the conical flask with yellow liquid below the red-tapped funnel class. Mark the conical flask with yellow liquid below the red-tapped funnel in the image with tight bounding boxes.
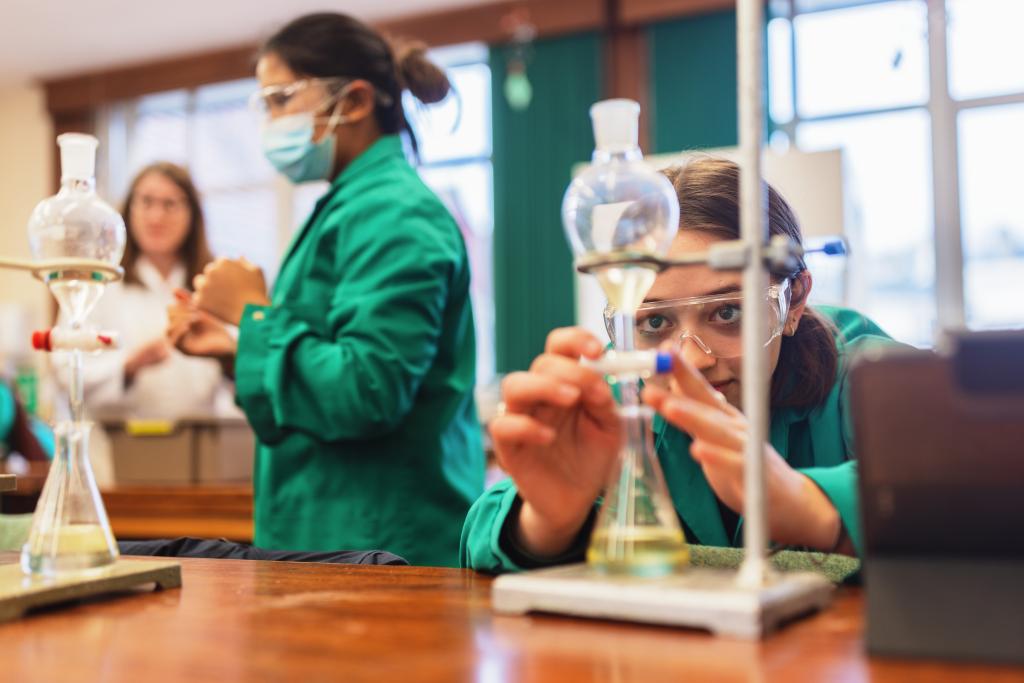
[22,422,118,575]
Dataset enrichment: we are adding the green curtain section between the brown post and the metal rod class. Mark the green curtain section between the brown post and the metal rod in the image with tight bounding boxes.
[648,11,737,153]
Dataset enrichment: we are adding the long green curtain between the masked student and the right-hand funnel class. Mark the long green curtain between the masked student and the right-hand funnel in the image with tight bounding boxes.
[490,34,602,373]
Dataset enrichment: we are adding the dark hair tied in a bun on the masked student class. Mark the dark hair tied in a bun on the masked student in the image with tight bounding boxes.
[259,12,452,155]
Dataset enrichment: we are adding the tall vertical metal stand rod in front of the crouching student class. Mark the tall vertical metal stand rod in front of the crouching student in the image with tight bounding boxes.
[736,0,771,588]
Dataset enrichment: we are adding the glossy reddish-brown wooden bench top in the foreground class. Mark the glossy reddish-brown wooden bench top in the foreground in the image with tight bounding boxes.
[0,555,1024,683]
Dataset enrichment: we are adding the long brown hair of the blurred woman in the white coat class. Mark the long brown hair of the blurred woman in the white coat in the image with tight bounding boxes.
[121,162,213,287]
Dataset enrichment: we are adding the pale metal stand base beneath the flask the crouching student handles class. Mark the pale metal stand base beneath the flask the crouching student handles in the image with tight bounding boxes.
[492,564,834,639]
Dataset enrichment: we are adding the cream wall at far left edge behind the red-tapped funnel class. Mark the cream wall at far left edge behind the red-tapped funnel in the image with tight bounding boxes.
[0,85,55,368]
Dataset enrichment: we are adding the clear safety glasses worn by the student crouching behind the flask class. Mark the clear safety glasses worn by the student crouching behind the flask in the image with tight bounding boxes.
[604,280,790,358]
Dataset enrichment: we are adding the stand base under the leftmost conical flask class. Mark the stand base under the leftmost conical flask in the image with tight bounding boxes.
[0,559,181,622]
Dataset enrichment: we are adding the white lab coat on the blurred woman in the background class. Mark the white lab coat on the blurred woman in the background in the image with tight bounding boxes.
[51,257,242,485]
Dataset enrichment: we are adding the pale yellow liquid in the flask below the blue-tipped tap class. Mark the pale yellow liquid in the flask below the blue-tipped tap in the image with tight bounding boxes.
[587,526,690,577]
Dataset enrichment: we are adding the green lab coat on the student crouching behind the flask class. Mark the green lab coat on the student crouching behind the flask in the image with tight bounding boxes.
[460,306,895,572]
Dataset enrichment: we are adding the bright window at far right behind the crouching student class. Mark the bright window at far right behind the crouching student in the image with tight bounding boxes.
[768,0,1024,346]
